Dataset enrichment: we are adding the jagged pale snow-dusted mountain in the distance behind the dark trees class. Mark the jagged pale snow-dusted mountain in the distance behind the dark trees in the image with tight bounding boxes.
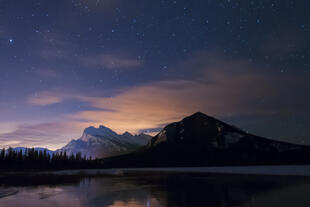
[57,126,151,158]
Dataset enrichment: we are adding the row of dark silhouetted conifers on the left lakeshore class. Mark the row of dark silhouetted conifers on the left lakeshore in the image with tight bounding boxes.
[0,148,101,170]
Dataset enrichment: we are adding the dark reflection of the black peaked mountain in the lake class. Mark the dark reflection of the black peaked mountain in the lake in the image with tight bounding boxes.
[140,174,309,207]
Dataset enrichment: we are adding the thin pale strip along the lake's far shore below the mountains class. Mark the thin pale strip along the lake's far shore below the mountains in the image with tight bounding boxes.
[0,165,310,177]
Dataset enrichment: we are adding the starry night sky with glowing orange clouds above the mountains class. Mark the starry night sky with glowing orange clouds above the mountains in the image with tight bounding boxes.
[0,0,310,149]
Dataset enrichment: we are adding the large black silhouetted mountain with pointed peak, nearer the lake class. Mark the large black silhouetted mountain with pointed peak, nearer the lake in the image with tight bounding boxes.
[103,112,310,167]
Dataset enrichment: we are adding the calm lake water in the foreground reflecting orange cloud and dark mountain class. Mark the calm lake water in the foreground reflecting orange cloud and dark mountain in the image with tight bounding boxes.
[0,174,310,207]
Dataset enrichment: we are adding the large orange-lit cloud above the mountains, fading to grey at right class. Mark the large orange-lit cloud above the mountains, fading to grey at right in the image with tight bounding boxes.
[72,54,310,132]
